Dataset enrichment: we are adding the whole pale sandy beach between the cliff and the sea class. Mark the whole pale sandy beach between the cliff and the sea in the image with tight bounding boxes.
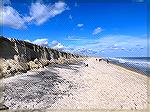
[3,58,148,110]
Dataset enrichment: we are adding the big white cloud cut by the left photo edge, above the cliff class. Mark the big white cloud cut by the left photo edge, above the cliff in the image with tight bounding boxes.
[0,6,26,29]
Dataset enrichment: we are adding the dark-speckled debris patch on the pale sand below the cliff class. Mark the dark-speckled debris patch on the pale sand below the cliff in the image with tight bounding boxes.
[3,65,81,109]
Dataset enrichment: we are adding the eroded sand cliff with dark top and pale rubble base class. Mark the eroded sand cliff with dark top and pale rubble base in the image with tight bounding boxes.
[0,36,81,78]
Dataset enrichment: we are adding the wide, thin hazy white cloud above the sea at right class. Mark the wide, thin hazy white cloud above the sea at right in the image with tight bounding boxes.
[99,35,147,48]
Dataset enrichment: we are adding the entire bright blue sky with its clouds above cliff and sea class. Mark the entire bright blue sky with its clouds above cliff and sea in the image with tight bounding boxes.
[0,0,147,57]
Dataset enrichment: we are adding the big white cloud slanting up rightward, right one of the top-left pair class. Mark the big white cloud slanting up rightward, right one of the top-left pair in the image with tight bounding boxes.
[26,1,67,25]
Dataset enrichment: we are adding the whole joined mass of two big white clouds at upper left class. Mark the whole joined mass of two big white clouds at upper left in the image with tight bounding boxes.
[0,0,68,29]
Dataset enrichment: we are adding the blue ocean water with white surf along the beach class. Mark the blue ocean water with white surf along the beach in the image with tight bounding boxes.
[107,57,150,76]
